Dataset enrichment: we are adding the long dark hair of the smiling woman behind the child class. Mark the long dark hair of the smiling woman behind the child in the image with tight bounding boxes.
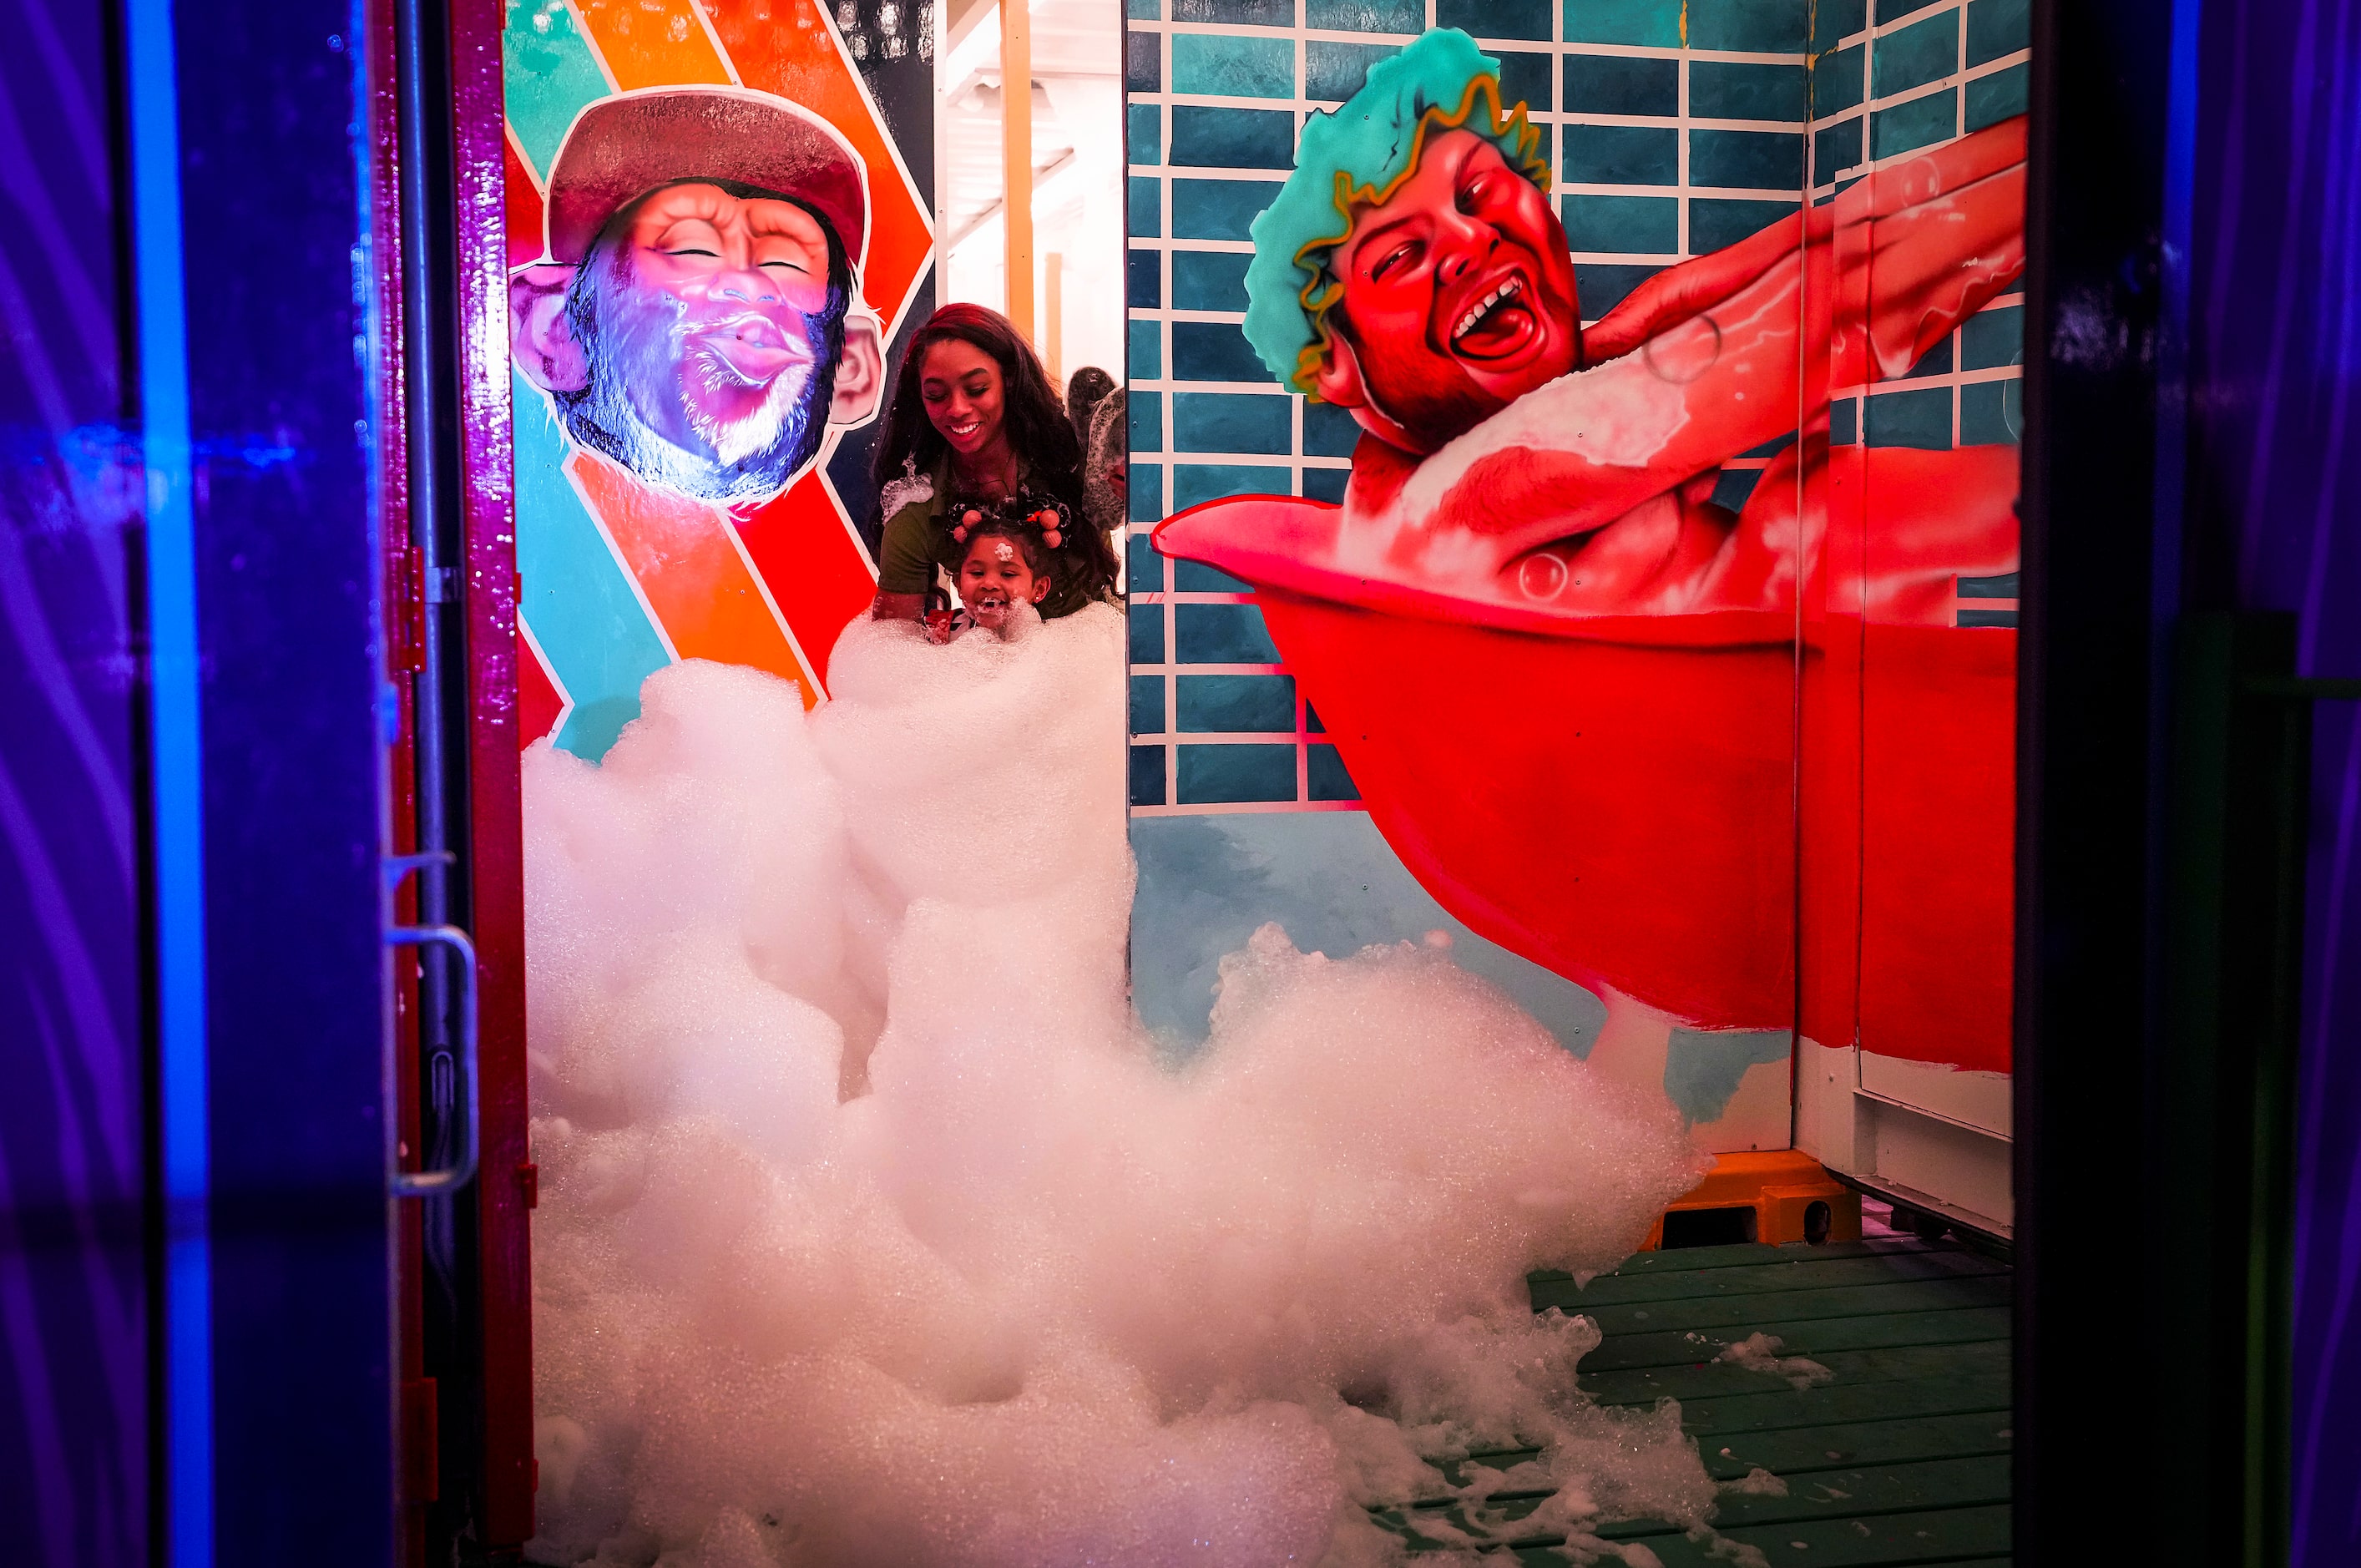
[873,305,1119,599]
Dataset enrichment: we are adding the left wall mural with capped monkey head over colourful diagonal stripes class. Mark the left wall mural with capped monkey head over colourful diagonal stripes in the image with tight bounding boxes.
[505,0,933,758]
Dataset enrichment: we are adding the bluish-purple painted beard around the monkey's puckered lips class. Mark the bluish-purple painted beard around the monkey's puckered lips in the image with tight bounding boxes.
[557,245,843,505]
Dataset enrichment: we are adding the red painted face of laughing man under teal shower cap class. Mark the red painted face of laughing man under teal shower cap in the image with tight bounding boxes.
[1317,130,1582,451]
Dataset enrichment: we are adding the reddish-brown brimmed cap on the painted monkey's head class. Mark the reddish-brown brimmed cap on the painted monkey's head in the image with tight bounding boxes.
[548,88,869,267]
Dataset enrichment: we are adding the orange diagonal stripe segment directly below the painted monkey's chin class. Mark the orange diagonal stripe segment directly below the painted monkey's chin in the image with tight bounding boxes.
[567,451,819,708]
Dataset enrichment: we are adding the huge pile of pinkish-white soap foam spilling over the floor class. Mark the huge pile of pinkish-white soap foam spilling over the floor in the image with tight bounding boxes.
[524,609,1714,1568]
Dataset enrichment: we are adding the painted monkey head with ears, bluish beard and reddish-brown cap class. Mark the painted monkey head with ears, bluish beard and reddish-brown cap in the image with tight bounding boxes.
[510,88,886,505]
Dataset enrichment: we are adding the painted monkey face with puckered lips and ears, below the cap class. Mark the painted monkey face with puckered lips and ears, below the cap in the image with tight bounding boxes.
[513,182,883,503]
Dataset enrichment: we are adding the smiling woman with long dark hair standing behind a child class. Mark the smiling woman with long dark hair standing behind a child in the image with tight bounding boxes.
[872,305,1117,621]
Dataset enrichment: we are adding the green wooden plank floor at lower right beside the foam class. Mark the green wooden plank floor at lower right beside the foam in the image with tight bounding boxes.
[1379,1237,2010,1568]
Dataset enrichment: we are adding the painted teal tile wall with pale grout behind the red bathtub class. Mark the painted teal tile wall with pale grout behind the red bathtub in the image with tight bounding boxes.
[1126,0,2028,1156]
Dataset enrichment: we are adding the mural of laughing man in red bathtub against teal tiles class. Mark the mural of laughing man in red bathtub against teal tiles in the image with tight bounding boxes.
[1133,5,2025,1190]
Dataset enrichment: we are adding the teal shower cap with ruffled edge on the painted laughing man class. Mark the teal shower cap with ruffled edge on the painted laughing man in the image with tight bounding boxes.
[1244,28,1549,394]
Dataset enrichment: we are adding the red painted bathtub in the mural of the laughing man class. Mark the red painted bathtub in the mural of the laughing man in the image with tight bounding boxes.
[1157,434,2016,1070]
